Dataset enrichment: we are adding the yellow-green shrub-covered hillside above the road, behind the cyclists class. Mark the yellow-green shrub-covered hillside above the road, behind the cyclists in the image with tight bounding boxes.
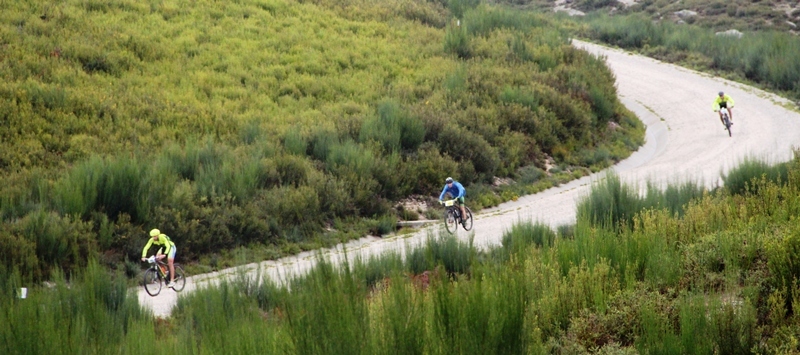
[0,0,643,280]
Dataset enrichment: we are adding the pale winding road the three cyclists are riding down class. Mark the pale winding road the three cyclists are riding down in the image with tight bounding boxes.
[137,41,800,316]
